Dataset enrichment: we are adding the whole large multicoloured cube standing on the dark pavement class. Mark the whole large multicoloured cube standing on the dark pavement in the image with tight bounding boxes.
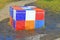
[10,6,45,30]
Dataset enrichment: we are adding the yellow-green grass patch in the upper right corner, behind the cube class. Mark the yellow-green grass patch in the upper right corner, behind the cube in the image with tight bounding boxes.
[36,0,60,13]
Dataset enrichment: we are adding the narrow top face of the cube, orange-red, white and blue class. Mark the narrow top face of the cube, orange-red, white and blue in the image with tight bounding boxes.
[10,6,44,11]
